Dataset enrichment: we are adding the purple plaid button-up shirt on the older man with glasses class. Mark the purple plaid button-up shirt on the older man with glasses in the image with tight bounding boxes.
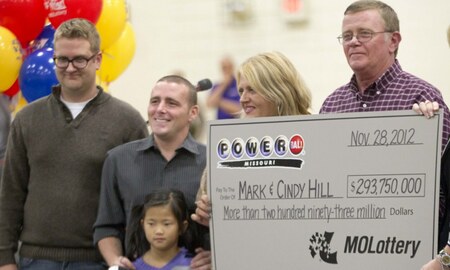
[320,60,450,152]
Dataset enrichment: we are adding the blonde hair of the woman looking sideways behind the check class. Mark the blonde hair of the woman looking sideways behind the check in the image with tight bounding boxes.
[236,52,311,116]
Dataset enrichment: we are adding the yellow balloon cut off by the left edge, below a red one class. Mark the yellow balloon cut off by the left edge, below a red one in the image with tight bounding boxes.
[0,26,22,92]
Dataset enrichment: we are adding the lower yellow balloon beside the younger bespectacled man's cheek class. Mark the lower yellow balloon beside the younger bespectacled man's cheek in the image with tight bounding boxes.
[97,22,136,83]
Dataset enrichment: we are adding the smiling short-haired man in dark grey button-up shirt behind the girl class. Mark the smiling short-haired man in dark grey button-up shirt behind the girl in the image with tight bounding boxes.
[94,75,211,270]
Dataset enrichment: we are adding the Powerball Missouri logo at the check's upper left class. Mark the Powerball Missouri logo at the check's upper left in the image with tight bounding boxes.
[216,134,305,168]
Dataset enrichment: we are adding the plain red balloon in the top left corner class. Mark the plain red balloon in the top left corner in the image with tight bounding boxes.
[0,0,48,47]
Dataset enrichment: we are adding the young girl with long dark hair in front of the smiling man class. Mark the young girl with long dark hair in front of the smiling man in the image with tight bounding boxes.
[126,189,194,270]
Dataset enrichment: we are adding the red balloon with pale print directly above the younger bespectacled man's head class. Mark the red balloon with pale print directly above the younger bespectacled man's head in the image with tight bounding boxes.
[46,0,103,29]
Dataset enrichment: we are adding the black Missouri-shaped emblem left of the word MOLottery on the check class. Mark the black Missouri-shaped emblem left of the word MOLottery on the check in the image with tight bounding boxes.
[309,232,337,264]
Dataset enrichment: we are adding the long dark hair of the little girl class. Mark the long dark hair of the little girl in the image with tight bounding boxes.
[125,189,197,260]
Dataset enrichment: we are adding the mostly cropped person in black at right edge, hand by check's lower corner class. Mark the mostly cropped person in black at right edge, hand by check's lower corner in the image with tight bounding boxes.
[421,22,450,270]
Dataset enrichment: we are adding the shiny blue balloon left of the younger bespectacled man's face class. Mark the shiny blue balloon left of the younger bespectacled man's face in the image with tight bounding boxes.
[19,48,58,103]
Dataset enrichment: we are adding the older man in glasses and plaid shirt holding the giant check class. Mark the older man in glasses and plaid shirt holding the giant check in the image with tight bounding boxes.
[320,0,450,265]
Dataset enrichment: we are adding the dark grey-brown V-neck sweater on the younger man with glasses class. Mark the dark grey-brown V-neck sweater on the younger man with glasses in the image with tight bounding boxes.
[0,87,148,266]
